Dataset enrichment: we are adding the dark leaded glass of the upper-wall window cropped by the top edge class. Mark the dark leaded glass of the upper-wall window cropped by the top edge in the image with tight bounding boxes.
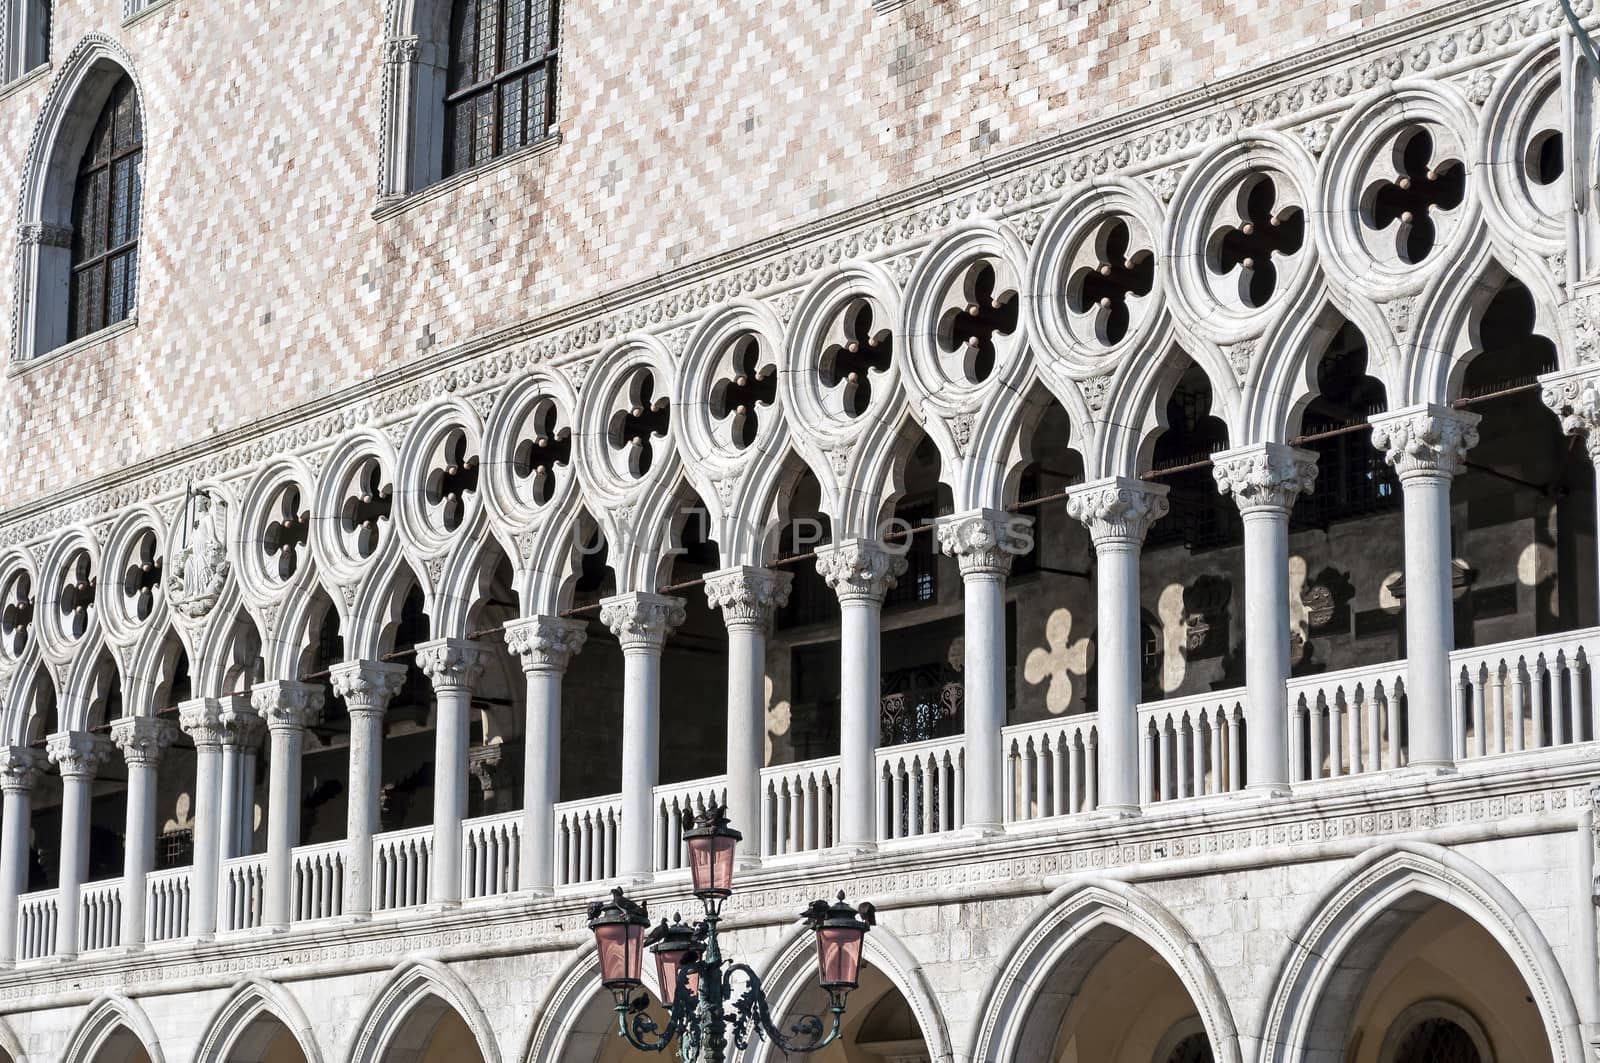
[445,0,557,178]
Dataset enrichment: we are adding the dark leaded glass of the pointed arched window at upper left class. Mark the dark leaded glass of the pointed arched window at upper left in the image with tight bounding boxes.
[67,77,144,339]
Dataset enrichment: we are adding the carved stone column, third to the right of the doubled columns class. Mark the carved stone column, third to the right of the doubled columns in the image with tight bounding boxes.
[416,639,486,905]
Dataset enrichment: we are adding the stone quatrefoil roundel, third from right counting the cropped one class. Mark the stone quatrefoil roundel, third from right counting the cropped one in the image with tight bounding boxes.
[1168,133,1312,343]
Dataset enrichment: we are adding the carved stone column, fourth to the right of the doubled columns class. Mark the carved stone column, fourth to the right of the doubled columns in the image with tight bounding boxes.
[506,616,589,893]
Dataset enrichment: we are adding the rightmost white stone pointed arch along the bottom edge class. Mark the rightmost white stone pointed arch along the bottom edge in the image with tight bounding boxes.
[1261,842,1584,1063]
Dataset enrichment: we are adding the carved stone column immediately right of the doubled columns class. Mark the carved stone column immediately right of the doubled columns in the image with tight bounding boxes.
[250,680,323,929]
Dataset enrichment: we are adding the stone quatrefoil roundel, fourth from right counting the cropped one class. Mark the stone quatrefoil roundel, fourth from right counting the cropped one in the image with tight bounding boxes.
[1029,181,1163,376]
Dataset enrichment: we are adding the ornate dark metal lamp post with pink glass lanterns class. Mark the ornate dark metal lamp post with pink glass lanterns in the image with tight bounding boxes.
[589,808,874,1063]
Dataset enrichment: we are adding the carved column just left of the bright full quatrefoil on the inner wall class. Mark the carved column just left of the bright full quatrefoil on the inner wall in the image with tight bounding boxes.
[938,509,1034,831]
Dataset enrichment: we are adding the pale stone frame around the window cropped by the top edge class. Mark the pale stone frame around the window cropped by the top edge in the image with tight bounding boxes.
[378,0,565,203]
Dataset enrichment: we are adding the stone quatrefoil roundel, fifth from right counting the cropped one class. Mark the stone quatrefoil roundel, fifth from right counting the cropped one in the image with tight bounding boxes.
[906,227,1026,411]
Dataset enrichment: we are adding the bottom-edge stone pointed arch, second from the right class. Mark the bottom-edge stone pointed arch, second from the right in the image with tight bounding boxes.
[971,879,1242,1063]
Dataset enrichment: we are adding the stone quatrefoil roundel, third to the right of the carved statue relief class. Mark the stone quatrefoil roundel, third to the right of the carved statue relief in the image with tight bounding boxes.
[393,402,483,554]
